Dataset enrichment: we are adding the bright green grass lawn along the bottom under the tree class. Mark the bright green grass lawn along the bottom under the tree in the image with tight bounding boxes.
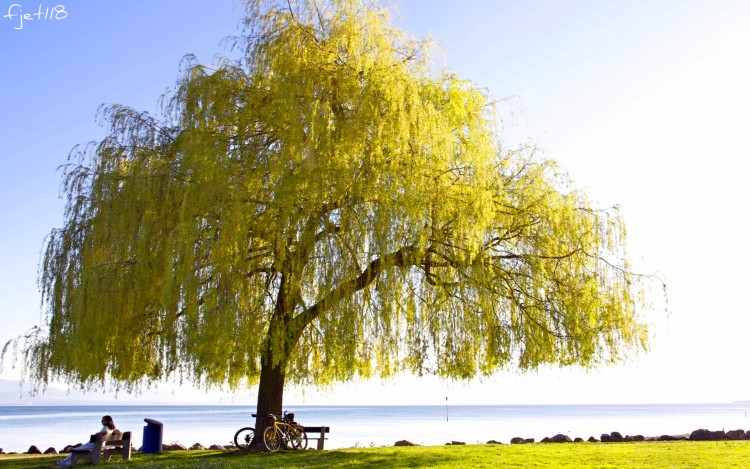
[0,441,750,469]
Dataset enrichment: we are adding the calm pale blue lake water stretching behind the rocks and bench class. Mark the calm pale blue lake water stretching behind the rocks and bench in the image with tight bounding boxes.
[0,403,750,452]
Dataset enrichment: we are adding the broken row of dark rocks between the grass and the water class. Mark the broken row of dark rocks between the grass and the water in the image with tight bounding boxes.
[0,429,750,454]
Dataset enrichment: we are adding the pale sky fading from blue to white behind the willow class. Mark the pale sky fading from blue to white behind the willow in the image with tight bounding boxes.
[0,0,750,404]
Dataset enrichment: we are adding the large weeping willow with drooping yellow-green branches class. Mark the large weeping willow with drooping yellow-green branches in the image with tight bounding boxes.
[6,0,646,442]
